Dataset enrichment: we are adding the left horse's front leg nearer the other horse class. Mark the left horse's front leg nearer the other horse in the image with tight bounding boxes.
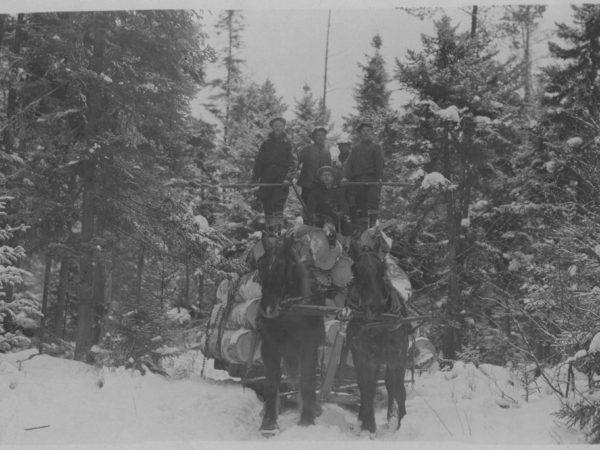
[300,336,318,426]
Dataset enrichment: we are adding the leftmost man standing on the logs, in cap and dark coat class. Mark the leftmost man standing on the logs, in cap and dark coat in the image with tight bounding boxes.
[252,117,297,233]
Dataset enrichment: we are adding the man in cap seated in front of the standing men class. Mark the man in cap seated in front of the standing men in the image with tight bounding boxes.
[307,166,349,243]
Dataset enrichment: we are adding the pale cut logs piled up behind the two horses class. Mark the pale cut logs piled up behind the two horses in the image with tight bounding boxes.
[202,225,412,365]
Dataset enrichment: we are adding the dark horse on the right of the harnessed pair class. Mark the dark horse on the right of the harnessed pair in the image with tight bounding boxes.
[347,239,410,433]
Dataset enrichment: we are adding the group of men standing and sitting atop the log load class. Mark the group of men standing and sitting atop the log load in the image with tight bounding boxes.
[252,117,383,235]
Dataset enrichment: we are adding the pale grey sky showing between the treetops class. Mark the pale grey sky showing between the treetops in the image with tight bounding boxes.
[195,4,571,130]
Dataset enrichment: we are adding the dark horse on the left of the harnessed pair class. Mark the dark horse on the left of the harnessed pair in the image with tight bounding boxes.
[257,233,325,433]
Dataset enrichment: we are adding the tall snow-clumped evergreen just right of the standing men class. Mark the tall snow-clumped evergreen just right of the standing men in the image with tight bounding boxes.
[396,16,516,358]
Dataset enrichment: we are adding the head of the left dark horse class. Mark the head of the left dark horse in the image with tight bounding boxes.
[257,233,300,319]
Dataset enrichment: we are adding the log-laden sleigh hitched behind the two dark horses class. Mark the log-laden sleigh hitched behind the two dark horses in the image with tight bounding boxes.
[202,229,436,405]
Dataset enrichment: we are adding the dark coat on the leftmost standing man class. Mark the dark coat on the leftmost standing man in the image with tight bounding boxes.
[252,133,298,183]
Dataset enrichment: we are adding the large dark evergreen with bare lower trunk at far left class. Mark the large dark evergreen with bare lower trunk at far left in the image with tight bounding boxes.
[0,11,212,359]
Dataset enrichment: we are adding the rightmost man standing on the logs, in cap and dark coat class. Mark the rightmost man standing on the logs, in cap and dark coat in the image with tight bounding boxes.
[341,123,383,228]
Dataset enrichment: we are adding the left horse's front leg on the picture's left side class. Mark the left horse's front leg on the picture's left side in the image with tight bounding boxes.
[260,339,281,431]
